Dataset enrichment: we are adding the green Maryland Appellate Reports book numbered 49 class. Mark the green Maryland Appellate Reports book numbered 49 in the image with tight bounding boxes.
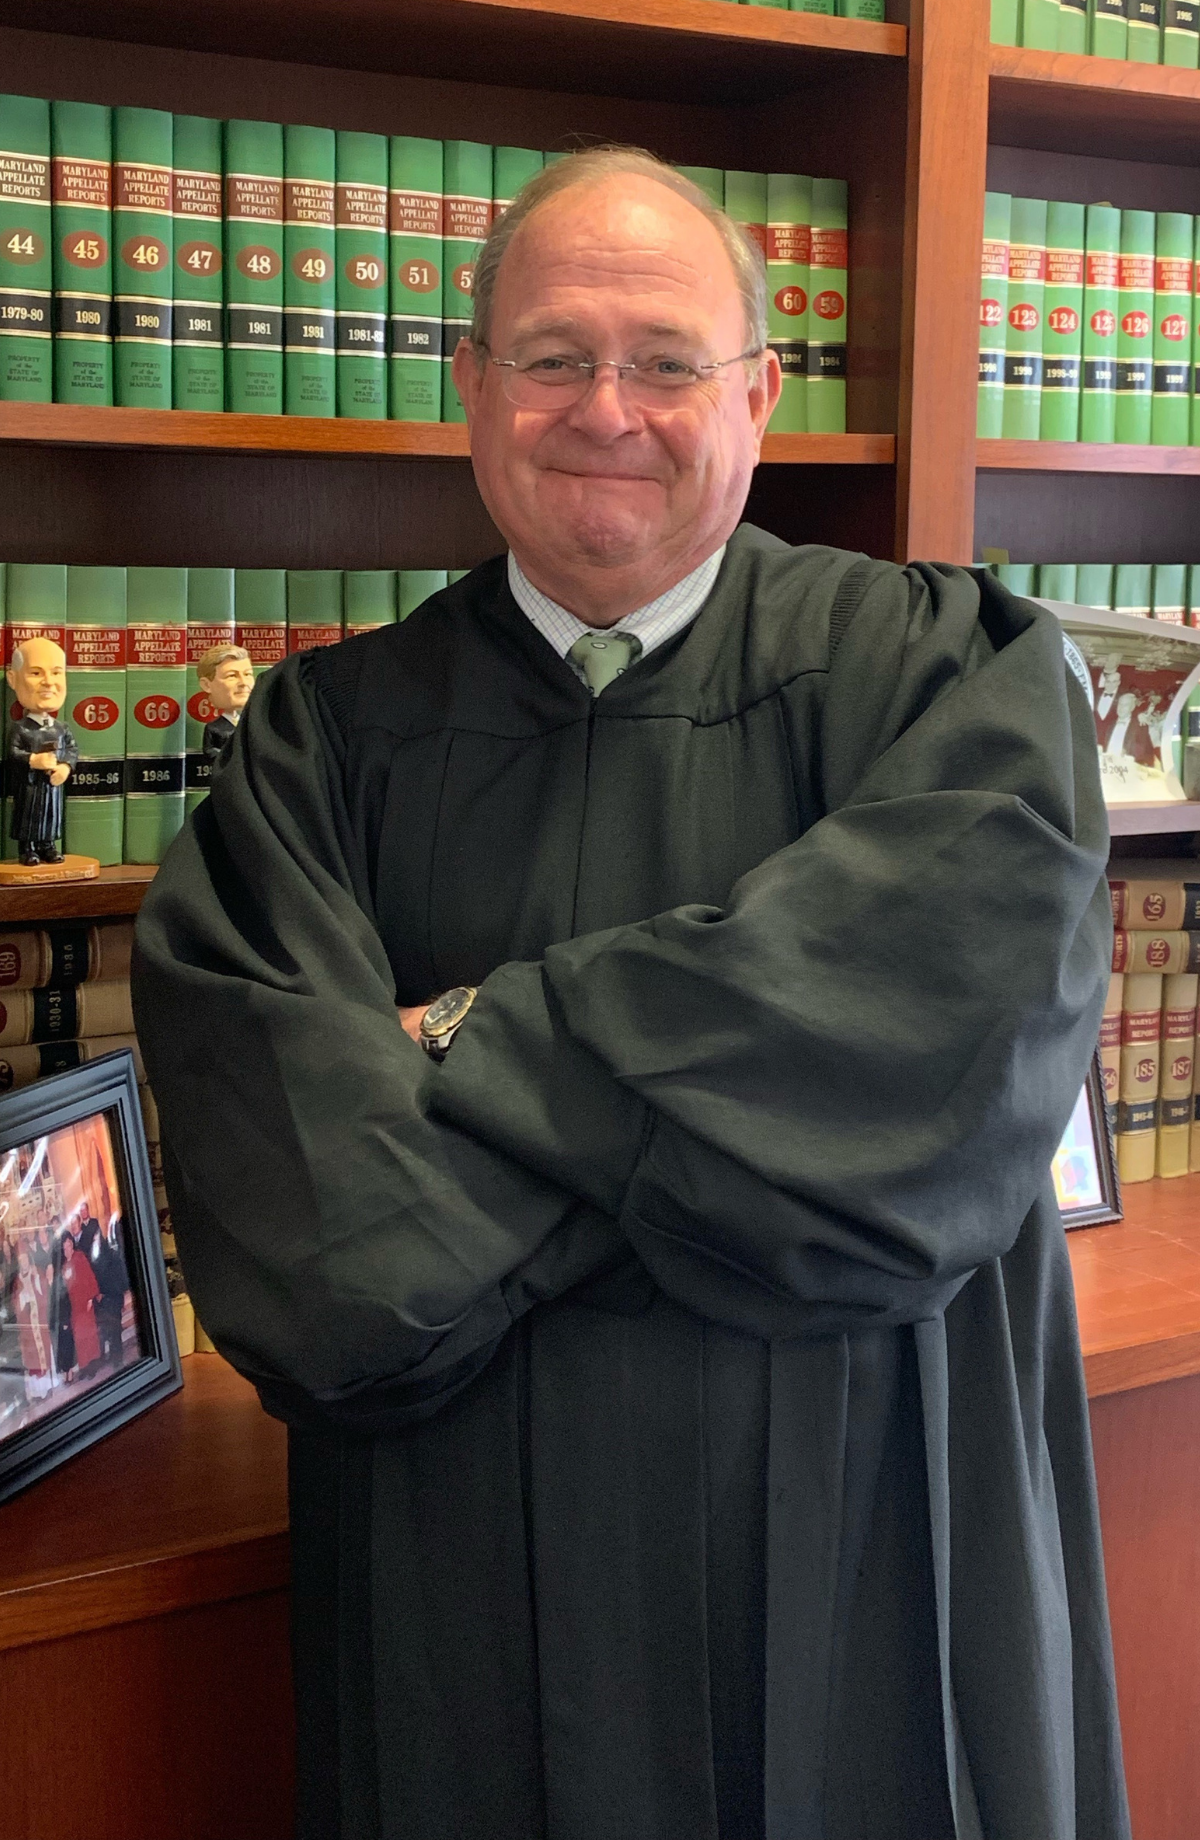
[283,125,337,416]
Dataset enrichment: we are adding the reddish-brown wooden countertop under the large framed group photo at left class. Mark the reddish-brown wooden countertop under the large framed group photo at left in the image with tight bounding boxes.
[0,1354,289,1650]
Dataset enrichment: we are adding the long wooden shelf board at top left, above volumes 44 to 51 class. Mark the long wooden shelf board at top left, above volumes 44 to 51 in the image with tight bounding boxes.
[0,0,907,103]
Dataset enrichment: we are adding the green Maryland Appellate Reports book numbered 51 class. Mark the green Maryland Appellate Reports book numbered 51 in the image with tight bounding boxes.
[388,134,442,421]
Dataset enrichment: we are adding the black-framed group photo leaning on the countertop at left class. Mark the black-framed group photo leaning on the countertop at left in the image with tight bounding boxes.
[0,1049,182,1501]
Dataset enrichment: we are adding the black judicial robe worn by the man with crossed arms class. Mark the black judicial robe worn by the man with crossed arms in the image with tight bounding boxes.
[134,526,1128,1840]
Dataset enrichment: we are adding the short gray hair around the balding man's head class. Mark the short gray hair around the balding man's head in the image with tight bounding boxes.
[471,147,767,350]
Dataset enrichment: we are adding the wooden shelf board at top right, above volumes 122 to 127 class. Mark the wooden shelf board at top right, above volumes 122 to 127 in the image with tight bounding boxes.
[988,44,1200,166]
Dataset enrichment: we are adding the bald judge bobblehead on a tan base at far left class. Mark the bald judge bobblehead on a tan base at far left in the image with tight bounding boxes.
[0,638,99,881]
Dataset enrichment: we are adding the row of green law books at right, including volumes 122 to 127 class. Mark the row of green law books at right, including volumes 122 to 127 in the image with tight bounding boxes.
[977,191,1200,447]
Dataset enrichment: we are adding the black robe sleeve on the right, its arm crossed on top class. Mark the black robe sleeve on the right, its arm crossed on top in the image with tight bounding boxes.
[429,565,1112,1336]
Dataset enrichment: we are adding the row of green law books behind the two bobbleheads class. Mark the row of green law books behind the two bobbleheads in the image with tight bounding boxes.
[0,563,466,865]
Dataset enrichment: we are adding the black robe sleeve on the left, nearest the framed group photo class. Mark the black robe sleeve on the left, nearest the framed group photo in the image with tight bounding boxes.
[133,659,642,1432]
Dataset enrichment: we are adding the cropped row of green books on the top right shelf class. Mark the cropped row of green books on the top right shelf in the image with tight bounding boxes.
[992,0,1200,70]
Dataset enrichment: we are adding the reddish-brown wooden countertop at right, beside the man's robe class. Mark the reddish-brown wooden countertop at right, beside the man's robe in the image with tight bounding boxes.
[1067,1176,1200,1398]
